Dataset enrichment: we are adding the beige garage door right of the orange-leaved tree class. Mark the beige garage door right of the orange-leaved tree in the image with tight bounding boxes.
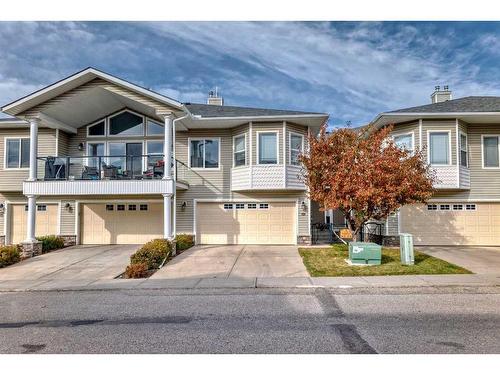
[400,203,500,245]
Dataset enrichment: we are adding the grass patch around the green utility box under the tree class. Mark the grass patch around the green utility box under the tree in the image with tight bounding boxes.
[299,244,472,276]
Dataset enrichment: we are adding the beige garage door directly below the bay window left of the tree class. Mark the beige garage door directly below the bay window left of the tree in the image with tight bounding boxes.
[196,202,297,244]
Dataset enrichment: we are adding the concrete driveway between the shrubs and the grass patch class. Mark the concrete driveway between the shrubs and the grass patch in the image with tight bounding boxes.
[151,245,309,279]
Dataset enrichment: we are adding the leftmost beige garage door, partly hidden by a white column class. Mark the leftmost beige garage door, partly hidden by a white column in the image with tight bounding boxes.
[10,204,59,244]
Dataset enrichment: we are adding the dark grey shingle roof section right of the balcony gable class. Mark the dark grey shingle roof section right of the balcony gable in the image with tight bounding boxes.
[184,103,328,117]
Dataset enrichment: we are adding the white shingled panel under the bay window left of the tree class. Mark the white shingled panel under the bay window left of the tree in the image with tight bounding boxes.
[231,165,306,191]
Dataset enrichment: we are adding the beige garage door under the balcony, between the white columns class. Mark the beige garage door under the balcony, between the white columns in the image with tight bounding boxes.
[80,203,163,244]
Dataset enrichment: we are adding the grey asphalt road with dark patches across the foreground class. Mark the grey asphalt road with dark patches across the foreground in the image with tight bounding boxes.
[0,288,500,353]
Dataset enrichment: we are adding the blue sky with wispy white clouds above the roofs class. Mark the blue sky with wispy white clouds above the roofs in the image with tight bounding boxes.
[0,22,500,125]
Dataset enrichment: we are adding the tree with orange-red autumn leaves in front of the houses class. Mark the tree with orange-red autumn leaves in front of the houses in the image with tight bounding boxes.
[301,125,435,238]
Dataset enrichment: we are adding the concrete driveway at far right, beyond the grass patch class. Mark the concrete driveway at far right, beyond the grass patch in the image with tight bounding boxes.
[418,246,500,274]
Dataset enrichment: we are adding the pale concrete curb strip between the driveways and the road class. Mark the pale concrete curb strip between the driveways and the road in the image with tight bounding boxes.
[0,274,500,292]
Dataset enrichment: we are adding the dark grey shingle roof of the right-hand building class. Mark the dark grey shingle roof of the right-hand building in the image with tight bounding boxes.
[389,96,500,113]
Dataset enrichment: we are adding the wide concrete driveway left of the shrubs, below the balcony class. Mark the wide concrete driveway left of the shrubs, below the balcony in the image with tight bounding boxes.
[0,245,140,280]
